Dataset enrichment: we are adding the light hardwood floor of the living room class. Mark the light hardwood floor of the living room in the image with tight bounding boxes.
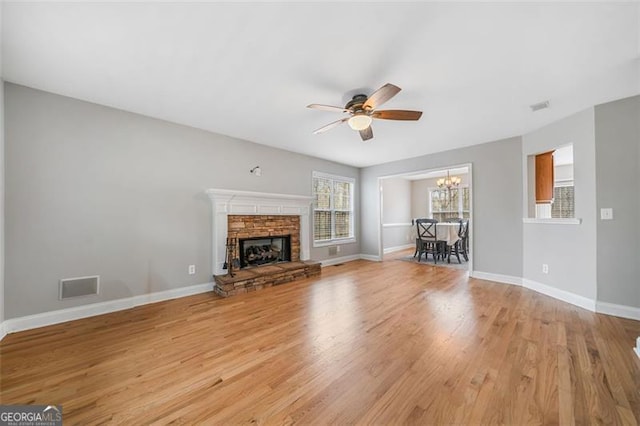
[0,255,640,425]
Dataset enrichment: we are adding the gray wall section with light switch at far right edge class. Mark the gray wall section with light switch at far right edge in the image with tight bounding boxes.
[595,96,640,308]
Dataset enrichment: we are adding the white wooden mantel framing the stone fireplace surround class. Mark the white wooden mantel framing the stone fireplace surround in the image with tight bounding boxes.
[206,188,313,275]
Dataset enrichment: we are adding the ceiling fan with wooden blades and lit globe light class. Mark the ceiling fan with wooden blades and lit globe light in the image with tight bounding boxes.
[307,83,422,141]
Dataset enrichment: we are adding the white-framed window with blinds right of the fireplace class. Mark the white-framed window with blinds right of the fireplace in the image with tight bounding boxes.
[313,172,354,245]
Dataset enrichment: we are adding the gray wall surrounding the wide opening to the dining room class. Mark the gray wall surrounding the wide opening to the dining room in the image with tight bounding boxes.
[360,137,522,277]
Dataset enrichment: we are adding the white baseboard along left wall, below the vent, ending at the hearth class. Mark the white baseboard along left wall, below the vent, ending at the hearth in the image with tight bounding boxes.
[2,283,213,334]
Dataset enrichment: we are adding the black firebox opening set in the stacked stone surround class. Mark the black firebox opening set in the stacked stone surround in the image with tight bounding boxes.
[238,235,291,268]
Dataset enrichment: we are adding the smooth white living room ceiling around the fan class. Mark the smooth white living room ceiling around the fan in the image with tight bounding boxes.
[2,1,640,166]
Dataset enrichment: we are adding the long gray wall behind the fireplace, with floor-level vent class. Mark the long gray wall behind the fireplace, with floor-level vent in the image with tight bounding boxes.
[5,83,360,318]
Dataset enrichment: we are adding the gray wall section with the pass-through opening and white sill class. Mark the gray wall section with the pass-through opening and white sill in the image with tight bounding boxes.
[521,108,597,300]
